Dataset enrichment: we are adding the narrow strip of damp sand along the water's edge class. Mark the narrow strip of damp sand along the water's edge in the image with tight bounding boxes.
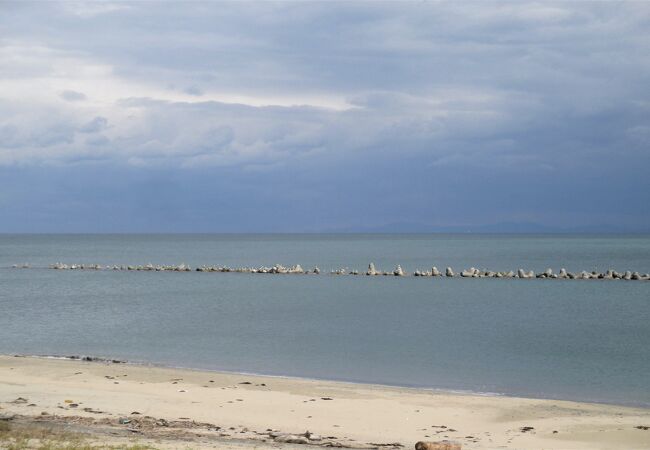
[11,353,650,411]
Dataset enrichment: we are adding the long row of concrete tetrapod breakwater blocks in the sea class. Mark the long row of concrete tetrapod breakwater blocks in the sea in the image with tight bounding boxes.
[12,262,650,281]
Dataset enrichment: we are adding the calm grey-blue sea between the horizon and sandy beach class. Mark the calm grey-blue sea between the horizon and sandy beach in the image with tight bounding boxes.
[0,235,650,407]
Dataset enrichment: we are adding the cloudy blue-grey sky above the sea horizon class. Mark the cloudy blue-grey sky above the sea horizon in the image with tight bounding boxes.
[0,0,650,233]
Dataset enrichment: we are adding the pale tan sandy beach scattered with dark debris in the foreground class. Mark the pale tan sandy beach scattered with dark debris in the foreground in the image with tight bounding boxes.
[0,356,650,449]
